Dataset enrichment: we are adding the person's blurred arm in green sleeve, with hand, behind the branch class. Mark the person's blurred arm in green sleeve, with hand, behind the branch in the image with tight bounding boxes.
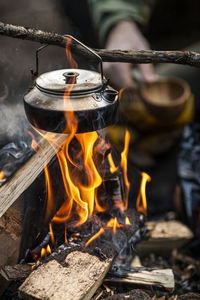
[88,0,155,89]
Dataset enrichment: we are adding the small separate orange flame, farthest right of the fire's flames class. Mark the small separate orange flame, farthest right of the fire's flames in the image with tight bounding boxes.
[136,172,151,215]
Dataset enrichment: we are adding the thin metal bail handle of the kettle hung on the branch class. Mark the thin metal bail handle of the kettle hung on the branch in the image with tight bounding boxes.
[31,34,105,85]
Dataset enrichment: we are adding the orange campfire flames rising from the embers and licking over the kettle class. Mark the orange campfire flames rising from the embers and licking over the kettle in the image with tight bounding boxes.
[21,36,150,268]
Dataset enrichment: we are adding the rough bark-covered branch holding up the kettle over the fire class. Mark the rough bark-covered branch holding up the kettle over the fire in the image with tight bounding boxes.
[0,22,200,67]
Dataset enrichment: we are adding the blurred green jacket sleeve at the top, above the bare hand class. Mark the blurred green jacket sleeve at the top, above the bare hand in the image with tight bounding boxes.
[88,0,156,46]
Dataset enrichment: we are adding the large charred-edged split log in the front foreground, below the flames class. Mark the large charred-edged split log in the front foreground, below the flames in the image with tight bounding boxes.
[19,251,112,300]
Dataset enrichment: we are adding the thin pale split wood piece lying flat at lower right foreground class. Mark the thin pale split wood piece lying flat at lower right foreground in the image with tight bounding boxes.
[104,267,175,292]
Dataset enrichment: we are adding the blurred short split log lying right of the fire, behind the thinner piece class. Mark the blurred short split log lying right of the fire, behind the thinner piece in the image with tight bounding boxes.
[136,221,193,255]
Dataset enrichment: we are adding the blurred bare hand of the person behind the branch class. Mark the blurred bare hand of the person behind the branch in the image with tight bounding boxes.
[103,21,154,89]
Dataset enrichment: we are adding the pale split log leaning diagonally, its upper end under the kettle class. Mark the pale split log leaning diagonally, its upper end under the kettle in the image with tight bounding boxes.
[0,134,66,217]
